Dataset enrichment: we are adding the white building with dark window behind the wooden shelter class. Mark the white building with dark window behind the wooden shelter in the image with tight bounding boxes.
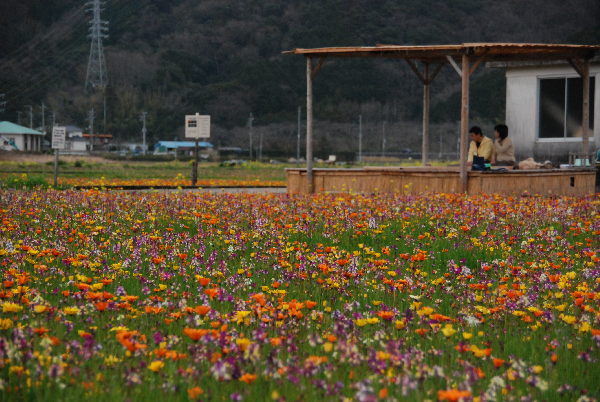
[504,58,600,162]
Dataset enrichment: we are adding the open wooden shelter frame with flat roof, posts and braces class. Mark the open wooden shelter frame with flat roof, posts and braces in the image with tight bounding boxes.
[284,43,600,193]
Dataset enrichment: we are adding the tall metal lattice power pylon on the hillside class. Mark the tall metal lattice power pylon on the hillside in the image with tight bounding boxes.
[85,0,108,91]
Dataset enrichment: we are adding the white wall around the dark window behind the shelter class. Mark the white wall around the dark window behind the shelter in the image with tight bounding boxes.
[506,64,600,163]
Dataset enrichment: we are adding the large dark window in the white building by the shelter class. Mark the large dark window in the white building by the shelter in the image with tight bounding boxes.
[539,77,596,138]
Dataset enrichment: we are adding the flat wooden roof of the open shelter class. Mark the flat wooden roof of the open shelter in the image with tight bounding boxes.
[283,43,600,63]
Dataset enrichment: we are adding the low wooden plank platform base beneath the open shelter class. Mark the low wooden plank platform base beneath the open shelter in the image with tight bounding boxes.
[286,167,596,196]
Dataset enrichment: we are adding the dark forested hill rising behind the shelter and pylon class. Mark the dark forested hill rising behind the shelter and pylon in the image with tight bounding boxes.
[0,0,600,144]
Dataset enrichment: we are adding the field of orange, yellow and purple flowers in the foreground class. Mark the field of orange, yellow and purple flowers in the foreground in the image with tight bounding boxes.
[0,189,600,401]
